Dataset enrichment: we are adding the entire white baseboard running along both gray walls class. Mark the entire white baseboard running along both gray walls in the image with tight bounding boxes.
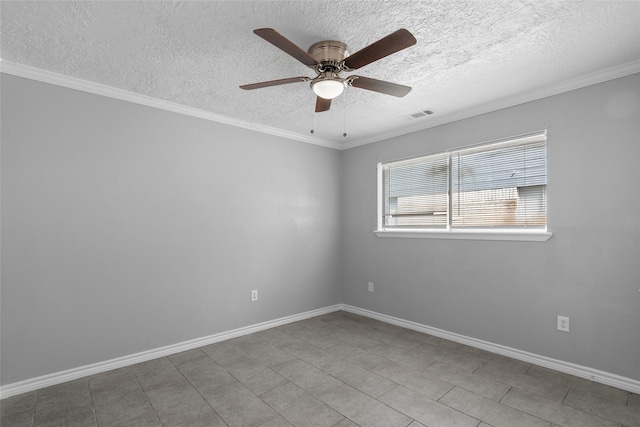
[0,304,640,399]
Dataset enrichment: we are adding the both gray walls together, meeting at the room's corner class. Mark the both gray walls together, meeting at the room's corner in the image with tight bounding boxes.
[0,74,640,384]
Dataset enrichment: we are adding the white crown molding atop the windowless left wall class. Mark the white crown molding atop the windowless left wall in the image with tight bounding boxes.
[0,60,343,150]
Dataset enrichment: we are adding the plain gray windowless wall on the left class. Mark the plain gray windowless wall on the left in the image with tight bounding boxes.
[1,74,341,384]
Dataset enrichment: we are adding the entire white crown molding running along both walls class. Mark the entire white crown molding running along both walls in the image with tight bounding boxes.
[0,60,640,150]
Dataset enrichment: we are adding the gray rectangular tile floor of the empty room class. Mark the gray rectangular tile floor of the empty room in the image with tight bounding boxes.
[0,312,640,427]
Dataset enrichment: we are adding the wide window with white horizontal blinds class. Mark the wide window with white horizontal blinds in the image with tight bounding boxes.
[376,132,551,240]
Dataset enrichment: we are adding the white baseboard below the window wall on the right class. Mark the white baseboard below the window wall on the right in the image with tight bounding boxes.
[342,304,640,394]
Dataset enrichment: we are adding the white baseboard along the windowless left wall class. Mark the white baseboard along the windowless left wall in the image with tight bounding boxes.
[0,304,342,399]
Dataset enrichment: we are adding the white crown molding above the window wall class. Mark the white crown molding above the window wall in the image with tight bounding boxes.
[341,60,640,150]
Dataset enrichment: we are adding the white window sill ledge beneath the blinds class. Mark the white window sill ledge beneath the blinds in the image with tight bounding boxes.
[374,229,553,242]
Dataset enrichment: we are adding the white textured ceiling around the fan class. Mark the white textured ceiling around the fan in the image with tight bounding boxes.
[0,0,640,144]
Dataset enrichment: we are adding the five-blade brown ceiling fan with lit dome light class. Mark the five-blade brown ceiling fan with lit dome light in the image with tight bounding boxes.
[240,28,416,113]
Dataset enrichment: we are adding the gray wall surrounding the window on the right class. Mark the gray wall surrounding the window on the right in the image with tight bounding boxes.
[342,74,640,380]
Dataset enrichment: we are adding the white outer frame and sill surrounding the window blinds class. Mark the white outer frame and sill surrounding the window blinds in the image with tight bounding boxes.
[374,131,553,242]
